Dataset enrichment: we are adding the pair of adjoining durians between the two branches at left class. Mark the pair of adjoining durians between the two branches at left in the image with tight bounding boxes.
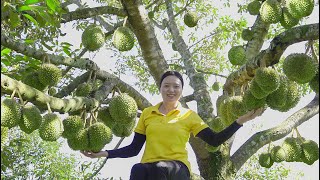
[22,63,62,91]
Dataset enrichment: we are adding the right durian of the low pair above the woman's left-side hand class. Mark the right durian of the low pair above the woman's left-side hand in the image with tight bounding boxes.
[88,122,112,152]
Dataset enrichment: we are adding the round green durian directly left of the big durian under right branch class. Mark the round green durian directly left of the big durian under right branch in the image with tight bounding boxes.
[254,67,280,94]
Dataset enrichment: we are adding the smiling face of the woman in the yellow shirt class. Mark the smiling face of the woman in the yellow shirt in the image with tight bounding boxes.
[160,75,182,102]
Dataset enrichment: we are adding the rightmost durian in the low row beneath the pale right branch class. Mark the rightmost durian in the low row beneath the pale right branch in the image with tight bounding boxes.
[301,140,319,165]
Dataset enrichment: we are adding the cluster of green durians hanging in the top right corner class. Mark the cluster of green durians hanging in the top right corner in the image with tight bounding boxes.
[247,0,314,29]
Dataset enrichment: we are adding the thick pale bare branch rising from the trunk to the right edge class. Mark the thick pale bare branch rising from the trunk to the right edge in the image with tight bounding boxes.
[231,95,319,170]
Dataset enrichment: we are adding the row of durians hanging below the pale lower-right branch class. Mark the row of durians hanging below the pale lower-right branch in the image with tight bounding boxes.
[259,137,319,168]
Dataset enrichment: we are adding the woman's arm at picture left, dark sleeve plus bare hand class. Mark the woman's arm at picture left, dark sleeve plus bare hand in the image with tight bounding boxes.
[81,132,146,158]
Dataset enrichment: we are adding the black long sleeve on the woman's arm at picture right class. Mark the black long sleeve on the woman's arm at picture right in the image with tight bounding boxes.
[196,121,242,146]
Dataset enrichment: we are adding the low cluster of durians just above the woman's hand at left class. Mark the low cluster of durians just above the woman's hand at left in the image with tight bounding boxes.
[62,115,113,152]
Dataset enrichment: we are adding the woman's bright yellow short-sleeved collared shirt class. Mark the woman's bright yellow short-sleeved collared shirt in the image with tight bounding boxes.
[134,103,208,172]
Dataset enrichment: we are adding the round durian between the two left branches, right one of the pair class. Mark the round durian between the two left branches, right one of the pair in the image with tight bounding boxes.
[38,63,62,86]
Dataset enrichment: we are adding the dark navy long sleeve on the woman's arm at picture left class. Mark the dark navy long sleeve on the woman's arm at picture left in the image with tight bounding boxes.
[107,132,146,158]
